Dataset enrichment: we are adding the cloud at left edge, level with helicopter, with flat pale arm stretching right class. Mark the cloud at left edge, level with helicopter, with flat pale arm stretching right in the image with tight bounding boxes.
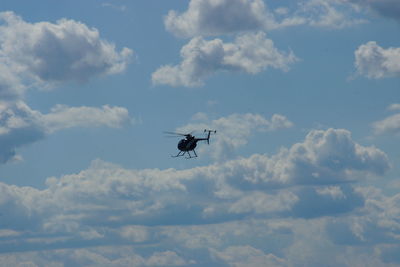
[0,101,131,163]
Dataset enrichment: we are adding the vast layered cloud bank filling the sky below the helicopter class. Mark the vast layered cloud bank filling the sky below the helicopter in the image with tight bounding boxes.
[0,129,392,266]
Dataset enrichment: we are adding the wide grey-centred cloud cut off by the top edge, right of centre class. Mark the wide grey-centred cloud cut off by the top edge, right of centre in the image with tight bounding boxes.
[164,0,365,37]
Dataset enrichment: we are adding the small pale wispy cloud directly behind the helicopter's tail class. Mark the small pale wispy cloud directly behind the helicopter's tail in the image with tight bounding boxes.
[177,113,293,160]
